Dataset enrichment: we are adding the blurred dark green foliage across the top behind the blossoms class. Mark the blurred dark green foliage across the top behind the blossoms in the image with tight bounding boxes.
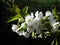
[2,0,60,12]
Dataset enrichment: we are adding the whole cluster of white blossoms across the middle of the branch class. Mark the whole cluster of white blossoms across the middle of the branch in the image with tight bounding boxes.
[12,11,59,38]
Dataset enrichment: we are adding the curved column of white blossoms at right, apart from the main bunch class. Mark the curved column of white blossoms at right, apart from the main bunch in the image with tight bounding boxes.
[46,11,59,32]
